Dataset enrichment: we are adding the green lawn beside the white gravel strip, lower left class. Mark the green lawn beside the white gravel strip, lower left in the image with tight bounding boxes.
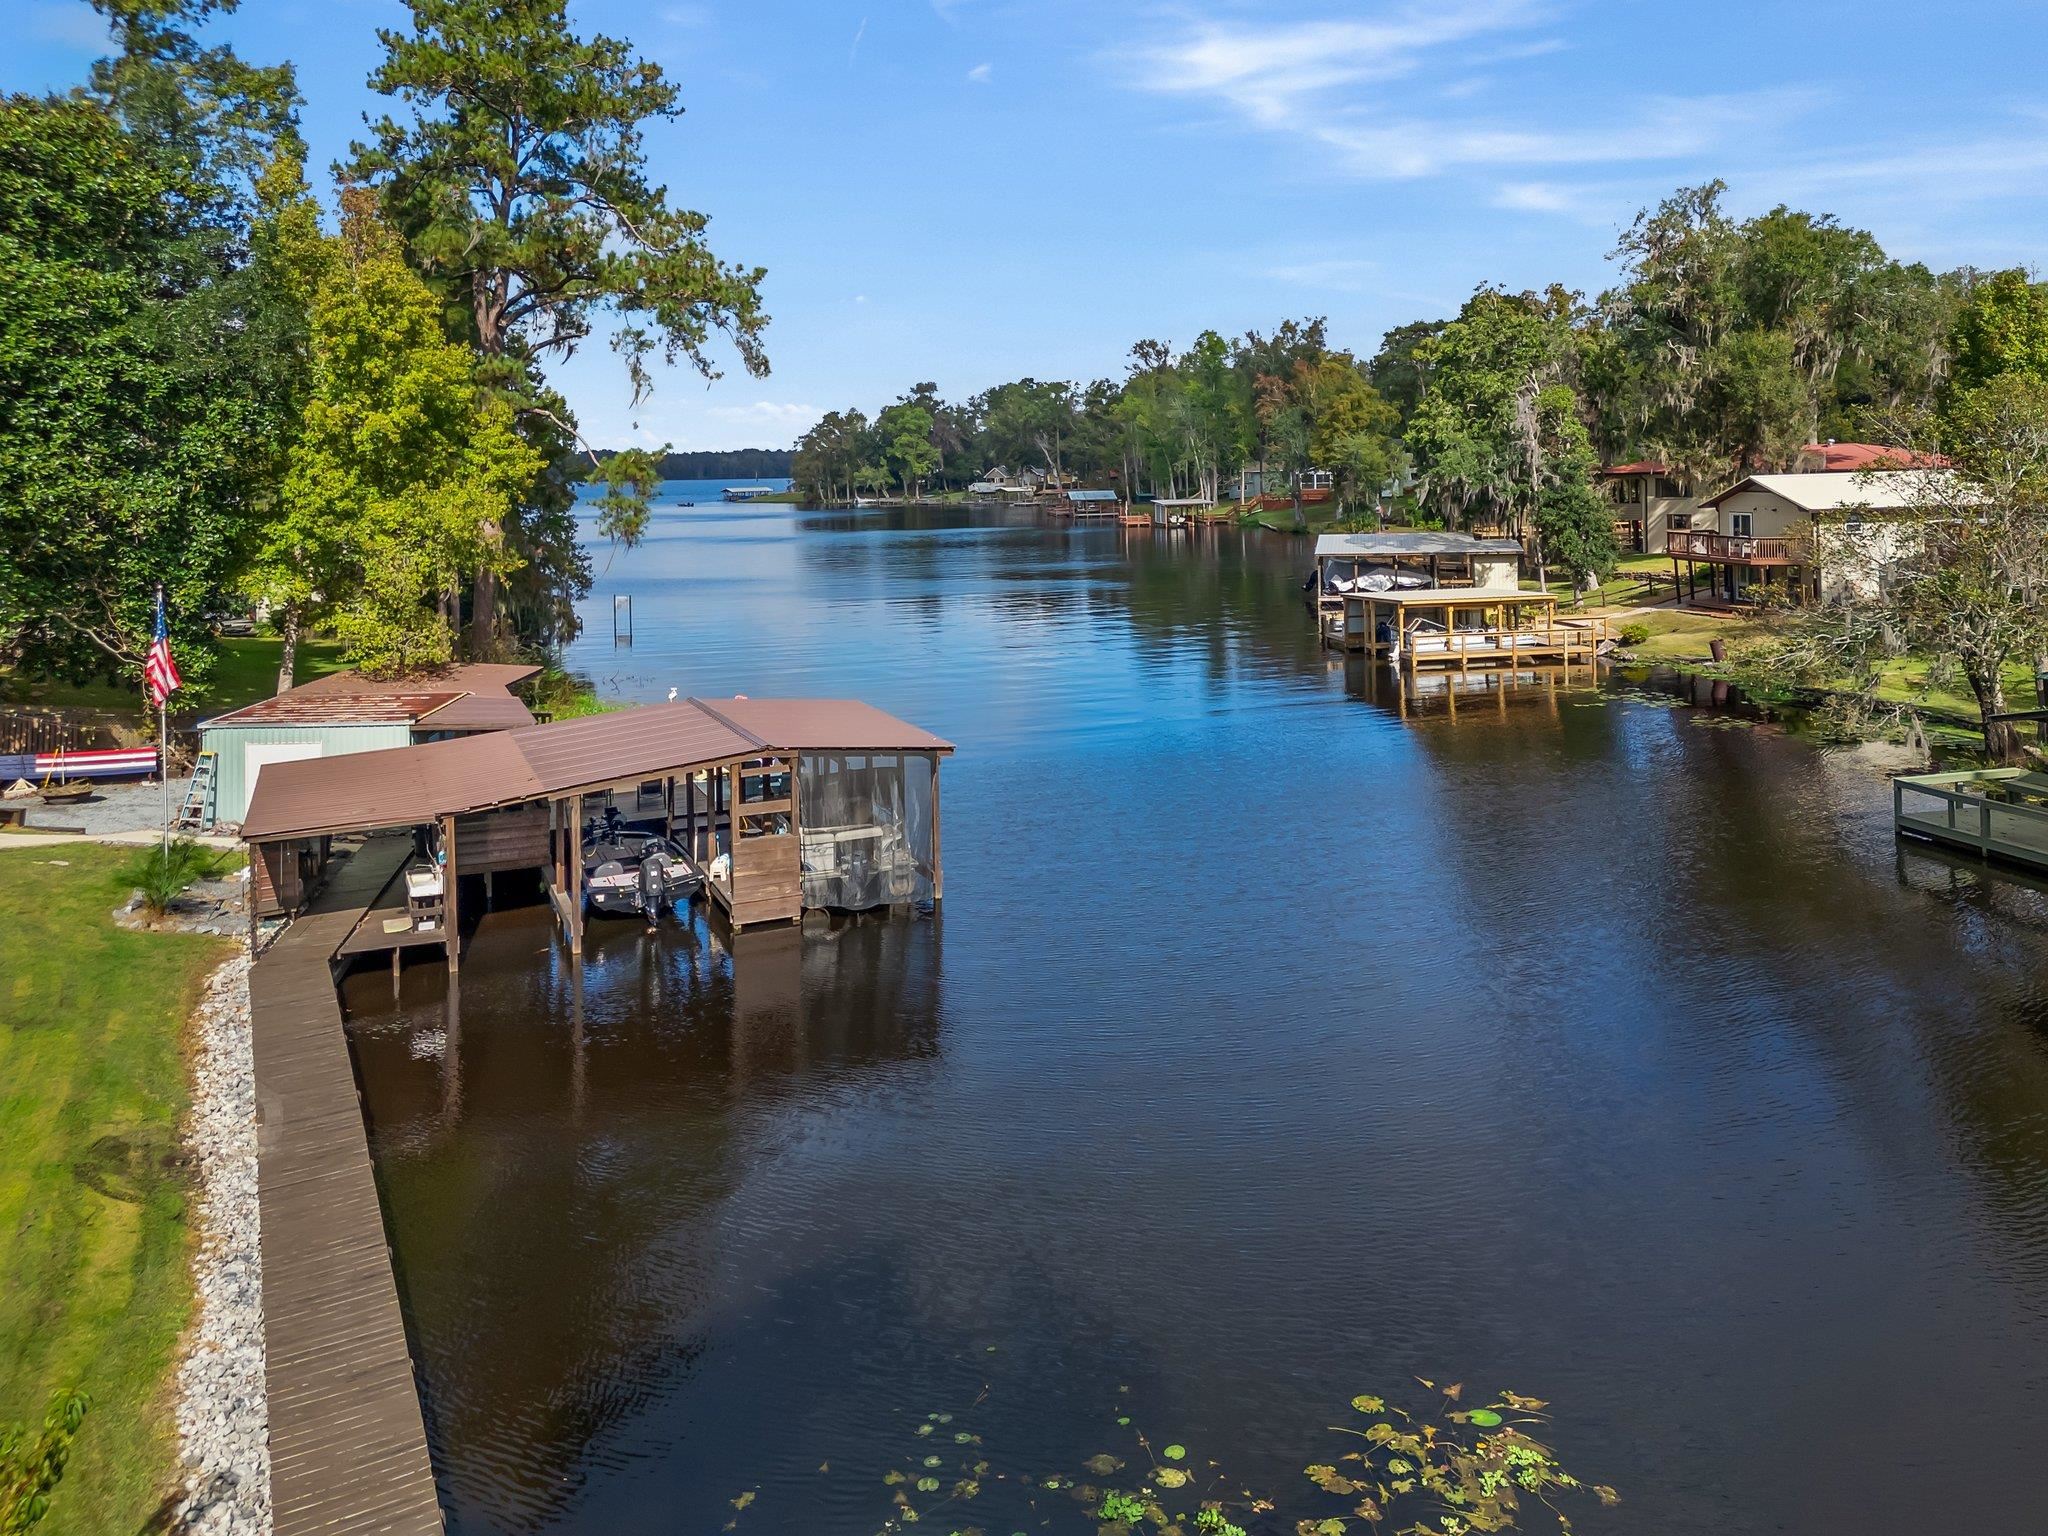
[0,844,231,1536]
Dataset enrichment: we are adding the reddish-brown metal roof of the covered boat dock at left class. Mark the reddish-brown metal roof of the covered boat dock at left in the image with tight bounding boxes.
[242,698,952,842]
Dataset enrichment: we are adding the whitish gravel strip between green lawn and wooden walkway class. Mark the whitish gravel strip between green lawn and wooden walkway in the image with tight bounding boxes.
[178,954,270,1536]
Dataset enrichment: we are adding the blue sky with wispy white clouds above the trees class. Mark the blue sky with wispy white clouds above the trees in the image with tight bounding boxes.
[16,0,2048,449]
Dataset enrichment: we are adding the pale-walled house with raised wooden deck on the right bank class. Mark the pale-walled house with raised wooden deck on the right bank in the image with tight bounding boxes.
[1665,469,1948,602]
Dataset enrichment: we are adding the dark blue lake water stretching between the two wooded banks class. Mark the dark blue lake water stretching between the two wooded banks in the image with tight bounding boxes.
[346,495,2048,1536]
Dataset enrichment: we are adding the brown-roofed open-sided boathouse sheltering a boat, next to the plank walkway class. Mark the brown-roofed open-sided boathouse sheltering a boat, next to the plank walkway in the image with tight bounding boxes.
[242,698,952,963]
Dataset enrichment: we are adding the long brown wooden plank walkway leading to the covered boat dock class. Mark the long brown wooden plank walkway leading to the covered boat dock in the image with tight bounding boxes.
[250,838,442,1536]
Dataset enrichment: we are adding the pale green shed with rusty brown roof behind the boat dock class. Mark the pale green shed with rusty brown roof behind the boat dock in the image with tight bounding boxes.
[199,664,541,825]
